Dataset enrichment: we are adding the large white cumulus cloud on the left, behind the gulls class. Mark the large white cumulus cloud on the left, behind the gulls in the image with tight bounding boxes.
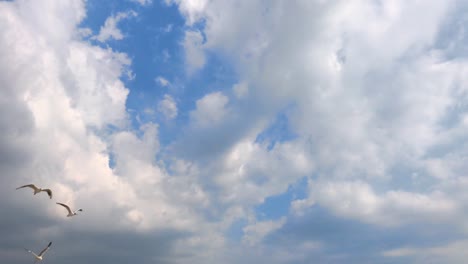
[0,0,210,263]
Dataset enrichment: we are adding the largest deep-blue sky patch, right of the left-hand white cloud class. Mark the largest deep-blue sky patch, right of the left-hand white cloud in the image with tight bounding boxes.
[81,0,237,145]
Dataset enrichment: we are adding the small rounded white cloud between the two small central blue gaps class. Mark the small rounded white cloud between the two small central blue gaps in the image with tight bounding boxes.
[217,139,313,206]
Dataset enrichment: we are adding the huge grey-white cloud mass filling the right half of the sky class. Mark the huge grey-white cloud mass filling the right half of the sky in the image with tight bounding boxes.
[168,0,467,262]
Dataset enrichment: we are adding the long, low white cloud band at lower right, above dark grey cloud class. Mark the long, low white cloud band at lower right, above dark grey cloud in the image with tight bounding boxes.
[304,182,459,226]
